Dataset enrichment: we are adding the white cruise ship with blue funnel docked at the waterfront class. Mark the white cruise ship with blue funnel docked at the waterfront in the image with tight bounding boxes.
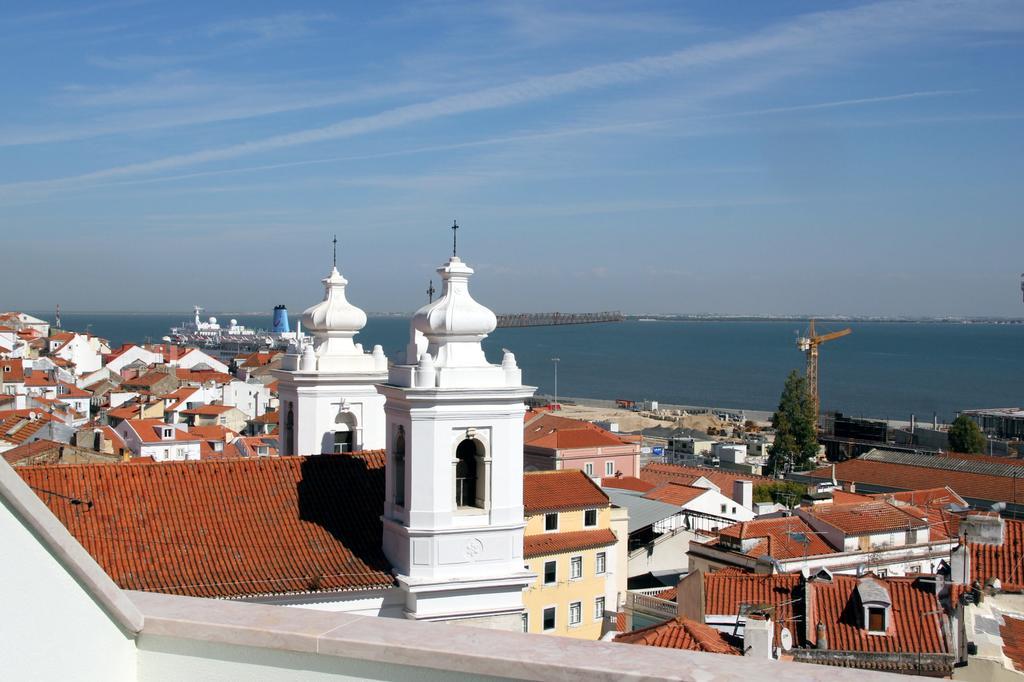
[164,305,301,358]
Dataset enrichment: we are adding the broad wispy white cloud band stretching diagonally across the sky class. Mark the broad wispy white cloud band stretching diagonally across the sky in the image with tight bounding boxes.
[0,0,1024,197]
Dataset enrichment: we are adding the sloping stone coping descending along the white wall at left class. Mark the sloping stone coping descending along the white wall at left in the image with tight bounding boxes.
[0,459,142,637]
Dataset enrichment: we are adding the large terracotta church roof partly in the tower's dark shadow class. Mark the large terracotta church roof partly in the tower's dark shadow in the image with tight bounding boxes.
[19,451,394,597]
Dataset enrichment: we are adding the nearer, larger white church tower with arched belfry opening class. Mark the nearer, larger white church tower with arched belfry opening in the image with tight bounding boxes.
[379,249,535,630]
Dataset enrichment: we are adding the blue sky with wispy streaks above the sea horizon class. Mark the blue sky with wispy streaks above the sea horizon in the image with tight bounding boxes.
[0,0,1024,315]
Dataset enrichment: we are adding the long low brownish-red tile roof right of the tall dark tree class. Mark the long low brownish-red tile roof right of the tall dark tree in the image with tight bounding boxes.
[809,459,1024,502]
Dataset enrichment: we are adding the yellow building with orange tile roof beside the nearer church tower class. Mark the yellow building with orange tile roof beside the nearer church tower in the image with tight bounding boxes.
[523,469,624,640]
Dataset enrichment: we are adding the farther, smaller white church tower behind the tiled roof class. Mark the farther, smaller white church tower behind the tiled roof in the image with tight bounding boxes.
[274,251,387,455]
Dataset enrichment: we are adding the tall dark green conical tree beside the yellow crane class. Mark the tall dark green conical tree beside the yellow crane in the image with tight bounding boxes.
[768,371,818,473]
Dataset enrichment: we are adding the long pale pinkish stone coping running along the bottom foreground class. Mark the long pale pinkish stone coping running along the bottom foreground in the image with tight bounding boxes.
[125,592,909,682]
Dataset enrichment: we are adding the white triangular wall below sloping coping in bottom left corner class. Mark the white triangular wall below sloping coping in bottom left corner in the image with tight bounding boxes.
[0,493,135,682]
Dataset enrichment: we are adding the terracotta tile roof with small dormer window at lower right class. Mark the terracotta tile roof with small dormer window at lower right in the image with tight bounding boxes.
[808,576,949,653]
